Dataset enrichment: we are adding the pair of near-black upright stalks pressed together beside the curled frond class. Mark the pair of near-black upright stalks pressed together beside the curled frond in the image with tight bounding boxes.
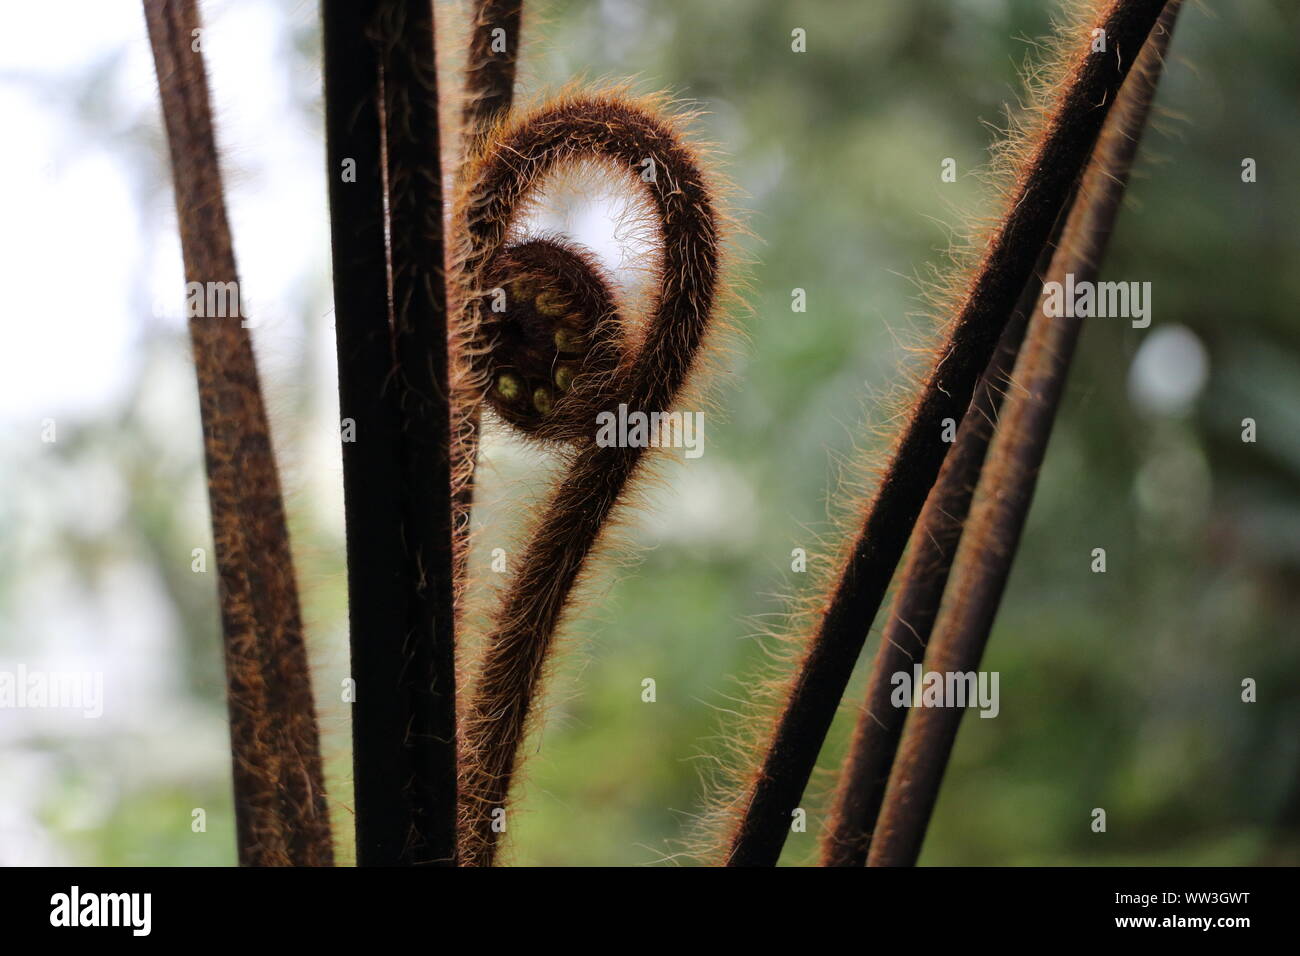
[322,0,456,865]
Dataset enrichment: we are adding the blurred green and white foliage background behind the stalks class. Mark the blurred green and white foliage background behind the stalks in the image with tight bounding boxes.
[0,0,1300,865]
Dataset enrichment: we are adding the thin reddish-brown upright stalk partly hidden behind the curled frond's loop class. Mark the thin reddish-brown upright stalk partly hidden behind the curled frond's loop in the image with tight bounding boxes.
[451,0,524,592]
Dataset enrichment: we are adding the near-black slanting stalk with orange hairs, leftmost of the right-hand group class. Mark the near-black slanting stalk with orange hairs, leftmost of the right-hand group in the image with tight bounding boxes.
[727,0,1164,866]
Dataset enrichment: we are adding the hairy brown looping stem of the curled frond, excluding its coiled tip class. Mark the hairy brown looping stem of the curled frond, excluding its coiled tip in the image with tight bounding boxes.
[455,95,719,866]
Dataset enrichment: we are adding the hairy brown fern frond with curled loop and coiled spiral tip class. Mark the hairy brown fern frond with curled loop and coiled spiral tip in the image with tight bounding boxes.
[452,92,722,865]
